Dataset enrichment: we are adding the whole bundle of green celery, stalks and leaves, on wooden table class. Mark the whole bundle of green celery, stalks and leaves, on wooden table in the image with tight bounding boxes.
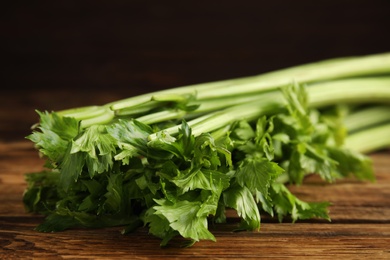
[24,53,390,246]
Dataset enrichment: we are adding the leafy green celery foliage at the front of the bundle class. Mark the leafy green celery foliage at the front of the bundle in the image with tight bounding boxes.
[23,52,386,246]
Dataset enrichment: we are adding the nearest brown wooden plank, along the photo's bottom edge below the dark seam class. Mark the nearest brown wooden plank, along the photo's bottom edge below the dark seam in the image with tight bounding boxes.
[0,217,390,259]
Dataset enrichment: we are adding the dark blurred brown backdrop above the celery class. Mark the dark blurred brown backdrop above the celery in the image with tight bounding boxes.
[0,0,390,139]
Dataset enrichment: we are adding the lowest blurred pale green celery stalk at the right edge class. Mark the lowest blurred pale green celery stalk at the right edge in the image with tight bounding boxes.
[344,124,390,154]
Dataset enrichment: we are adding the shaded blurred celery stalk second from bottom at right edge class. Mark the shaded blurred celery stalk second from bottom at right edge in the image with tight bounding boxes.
[344,105,390,134]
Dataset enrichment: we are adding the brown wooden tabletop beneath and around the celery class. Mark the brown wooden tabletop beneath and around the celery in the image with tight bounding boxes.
[0,88,390,259]
